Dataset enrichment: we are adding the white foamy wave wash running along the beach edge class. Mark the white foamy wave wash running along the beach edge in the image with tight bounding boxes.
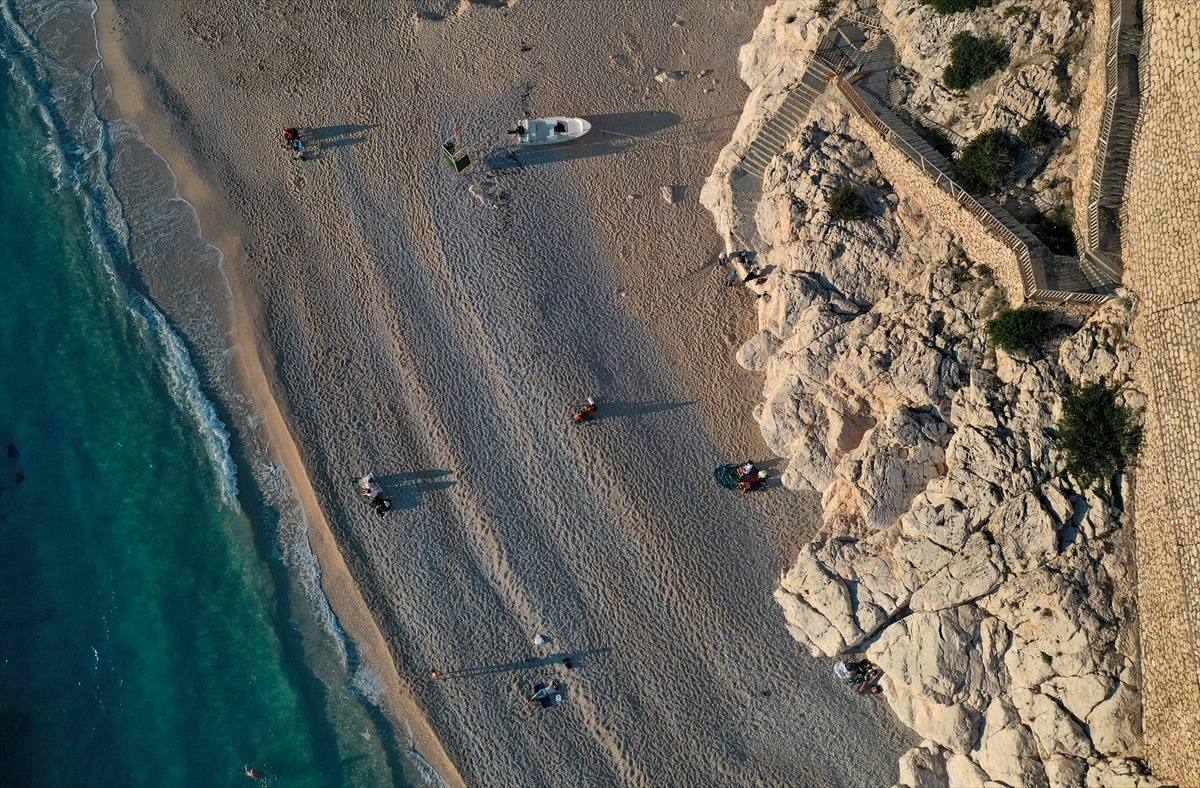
[7,0,415,772]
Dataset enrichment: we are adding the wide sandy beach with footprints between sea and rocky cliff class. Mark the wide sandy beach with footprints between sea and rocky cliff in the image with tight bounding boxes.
[98,0,913,787]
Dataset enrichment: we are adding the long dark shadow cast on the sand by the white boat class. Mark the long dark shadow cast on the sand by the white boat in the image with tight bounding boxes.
[484,112,679,170]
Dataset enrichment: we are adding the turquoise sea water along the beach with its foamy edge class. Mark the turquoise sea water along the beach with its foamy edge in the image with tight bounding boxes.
[0,7,412,786]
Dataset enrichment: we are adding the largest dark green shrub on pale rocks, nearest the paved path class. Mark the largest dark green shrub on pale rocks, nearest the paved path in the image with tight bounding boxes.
[1057,383,1141,489]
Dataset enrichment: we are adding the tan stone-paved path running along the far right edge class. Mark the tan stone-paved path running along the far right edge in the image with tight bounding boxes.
[1124,1,1200,786]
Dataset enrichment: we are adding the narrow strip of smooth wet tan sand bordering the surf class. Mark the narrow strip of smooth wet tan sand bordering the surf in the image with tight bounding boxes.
[87,0,464,788]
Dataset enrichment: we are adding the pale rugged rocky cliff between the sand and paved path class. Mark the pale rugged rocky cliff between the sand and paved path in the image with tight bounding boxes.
[702,0,1158,788]
